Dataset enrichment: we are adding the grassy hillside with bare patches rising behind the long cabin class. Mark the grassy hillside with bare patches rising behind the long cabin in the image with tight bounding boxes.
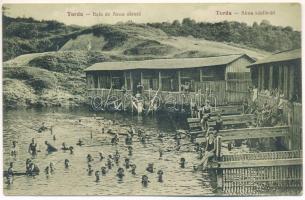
[3,16,270,107]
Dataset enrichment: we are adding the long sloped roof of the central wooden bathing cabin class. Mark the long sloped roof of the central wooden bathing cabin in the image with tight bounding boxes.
[84,54,254,72]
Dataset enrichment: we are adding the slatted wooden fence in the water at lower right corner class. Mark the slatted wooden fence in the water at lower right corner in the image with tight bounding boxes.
[217,151,303,195]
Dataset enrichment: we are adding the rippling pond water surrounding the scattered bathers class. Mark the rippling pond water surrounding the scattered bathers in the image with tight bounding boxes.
[3,110,213,196]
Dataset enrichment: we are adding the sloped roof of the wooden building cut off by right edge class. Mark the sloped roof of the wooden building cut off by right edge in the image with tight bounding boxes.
[247,49,302,67]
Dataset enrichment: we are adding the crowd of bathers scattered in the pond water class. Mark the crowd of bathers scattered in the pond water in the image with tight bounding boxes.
[6,119,213,186]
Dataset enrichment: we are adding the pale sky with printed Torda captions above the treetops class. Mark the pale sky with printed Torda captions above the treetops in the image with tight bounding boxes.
[4,3,301,30]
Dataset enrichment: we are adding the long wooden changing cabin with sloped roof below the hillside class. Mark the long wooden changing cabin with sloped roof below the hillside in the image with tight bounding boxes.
[84,54,254,111]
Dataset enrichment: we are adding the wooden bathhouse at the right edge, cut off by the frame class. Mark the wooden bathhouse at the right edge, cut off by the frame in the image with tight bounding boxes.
[248,49,302,149]
